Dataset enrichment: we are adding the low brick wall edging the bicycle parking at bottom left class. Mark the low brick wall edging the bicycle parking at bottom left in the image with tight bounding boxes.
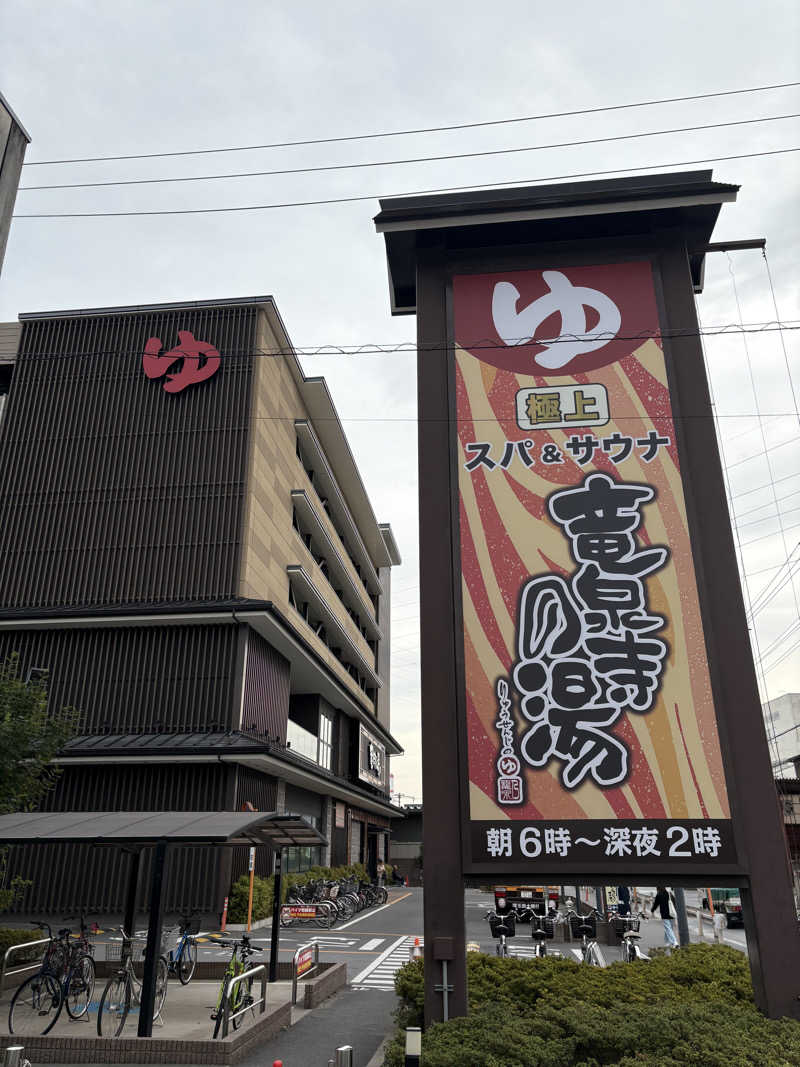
[10,1002,291,1067]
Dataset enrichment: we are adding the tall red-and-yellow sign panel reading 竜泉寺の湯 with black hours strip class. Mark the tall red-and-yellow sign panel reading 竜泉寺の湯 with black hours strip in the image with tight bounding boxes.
[452,259,736,873]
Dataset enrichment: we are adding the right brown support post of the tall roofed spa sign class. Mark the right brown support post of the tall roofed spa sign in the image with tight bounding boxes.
[660,233,800,1019]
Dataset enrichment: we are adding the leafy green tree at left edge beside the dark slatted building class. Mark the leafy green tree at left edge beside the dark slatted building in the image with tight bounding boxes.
[0,654,78,908]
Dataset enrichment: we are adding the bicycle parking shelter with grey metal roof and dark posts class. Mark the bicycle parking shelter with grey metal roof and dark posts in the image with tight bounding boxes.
[0,811,327,1037]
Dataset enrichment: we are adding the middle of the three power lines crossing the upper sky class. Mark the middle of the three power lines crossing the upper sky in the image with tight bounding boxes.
[19,112,800,192]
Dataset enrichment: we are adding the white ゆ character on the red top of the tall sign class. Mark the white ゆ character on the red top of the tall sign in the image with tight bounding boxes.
[492,270,622,369]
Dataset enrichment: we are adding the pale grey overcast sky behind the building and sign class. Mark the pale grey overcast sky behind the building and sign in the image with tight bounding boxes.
[0,0,800,799]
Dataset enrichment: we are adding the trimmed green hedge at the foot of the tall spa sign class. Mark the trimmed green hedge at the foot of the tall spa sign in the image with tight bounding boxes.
[385,945,800,1067]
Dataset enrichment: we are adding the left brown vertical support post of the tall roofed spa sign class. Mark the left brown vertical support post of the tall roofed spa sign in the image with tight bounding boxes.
[417,246,467,1025]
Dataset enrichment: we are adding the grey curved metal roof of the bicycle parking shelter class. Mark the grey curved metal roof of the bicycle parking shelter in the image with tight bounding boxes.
[0,811,327,848]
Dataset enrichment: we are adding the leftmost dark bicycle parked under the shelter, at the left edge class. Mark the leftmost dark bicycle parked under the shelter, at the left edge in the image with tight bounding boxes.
[9,914,95,1037]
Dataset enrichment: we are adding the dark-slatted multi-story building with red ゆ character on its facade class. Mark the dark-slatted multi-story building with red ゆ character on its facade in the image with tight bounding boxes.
[0,297,401,911]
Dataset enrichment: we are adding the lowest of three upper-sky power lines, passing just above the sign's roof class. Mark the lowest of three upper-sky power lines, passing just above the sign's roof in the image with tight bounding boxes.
[12,146,800,219]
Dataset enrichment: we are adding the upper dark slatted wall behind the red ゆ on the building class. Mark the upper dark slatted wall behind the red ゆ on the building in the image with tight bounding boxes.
[0,307,257,608]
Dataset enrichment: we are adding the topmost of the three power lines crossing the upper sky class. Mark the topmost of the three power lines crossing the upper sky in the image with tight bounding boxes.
[23,81,800,166]
